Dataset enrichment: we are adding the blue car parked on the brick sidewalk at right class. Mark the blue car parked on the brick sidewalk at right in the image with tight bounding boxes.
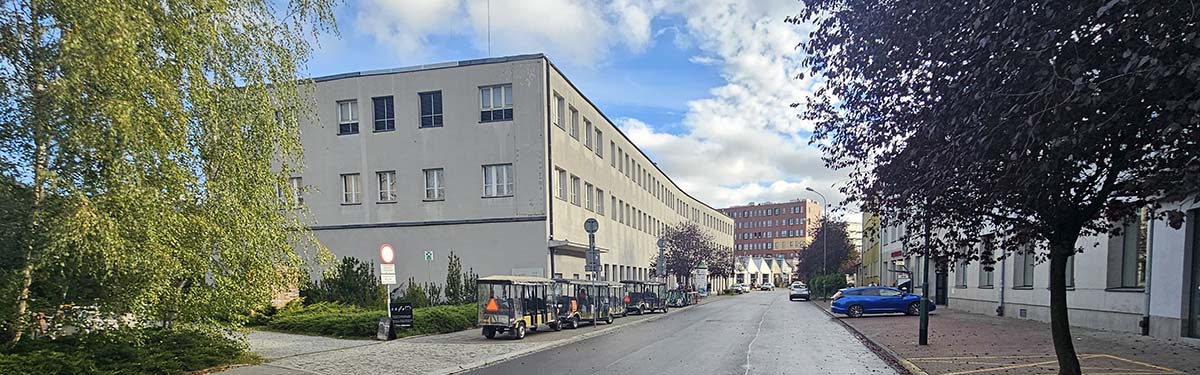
[830,286,937,317]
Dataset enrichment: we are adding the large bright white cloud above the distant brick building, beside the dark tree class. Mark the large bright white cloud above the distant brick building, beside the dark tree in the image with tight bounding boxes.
[609,0,846,213]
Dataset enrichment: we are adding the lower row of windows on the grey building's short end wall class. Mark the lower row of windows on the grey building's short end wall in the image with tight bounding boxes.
[289,163,514,206]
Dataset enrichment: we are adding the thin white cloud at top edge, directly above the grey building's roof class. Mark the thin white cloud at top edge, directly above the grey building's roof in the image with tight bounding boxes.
[354,0,658,65]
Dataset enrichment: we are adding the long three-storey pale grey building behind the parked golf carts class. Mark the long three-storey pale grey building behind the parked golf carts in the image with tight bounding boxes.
[293,54,733,288]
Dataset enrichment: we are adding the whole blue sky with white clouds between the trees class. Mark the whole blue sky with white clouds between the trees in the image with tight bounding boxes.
[307,0,857,220]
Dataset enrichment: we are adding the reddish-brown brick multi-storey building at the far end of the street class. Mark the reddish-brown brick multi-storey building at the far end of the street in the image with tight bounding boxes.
[720,200,821,258]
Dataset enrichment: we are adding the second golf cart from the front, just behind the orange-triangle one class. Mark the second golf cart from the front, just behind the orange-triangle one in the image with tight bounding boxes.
[554,279,612,329]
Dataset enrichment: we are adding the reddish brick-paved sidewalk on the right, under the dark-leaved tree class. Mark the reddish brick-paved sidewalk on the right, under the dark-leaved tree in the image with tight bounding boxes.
[815,302,1200,375]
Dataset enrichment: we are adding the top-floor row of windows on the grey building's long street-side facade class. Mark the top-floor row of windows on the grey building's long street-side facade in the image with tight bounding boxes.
[554,93,732,233]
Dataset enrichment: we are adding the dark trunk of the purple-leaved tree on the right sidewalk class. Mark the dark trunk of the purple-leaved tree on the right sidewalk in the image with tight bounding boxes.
[1050,235,1080,375]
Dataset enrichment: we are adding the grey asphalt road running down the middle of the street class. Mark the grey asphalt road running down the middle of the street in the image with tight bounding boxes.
[467,290,896,375]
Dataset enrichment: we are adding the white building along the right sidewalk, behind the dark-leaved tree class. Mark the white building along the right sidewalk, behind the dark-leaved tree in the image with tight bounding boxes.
[864,198,1200,338]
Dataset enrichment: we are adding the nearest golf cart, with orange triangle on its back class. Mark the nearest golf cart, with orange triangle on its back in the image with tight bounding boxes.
[478,275,559,340]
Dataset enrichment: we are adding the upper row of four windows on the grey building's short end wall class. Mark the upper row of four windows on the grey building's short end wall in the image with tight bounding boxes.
[337,84,512,136]
